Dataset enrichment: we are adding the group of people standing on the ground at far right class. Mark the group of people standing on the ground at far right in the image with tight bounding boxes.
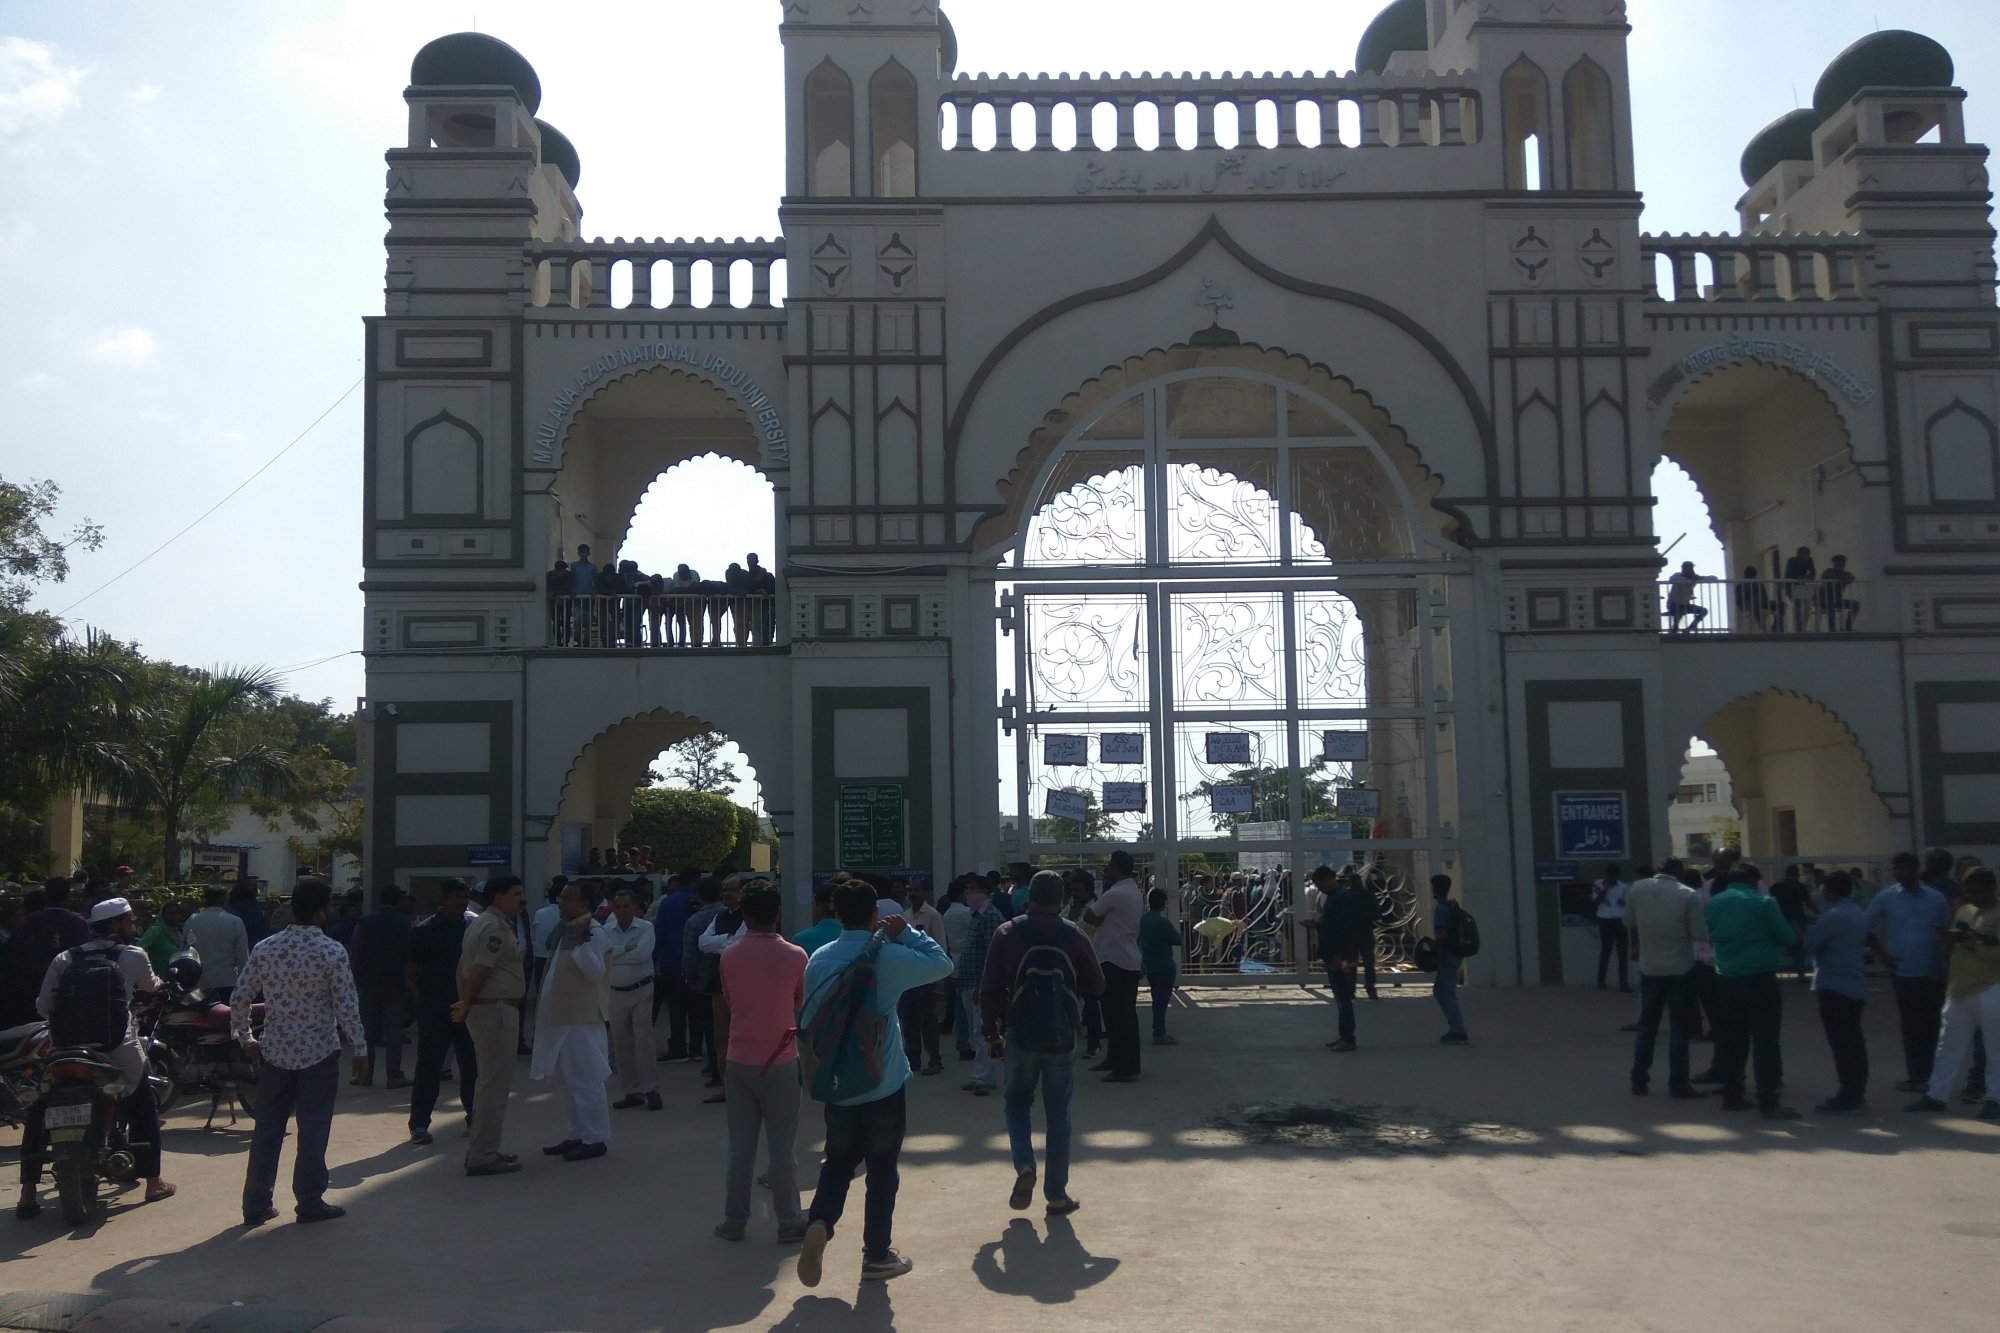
[1594,847,2000,1121]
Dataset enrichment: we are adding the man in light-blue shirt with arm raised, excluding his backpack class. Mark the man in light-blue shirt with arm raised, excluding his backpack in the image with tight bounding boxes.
[798,881,952,1287]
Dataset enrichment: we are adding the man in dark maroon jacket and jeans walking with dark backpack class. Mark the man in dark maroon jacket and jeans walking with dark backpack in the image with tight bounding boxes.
[980,871,1104,1217]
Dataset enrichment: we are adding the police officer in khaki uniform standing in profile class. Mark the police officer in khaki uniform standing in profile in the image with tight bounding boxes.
[452,875,528,1175]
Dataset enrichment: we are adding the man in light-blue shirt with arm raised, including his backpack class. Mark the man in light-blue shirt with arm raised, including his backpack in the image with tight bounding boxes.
[798,881,952,1287]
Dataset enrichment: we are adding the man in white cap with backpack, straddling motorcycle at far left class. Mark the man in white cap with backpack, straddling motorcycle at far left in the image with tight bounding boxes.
[14,899,174,1219]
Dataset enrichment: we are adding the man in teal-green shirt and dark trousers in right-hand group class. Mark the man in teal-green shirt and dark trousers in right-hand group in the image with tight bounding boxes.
[1702,865,1798,1121]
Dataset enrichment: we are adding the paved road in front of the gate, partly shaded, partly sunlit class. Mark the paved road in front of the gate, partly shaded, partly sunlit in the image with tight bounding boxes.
[0,987,2000,1333]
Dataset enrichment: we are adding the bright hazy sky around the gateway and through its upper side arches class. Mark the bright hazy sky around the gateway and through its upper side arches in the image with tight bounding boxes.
[0,0,2000,740]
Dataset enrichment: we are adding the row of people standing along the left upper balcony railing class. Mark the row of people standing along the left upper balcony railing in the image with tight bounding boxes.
[542,546,778,648]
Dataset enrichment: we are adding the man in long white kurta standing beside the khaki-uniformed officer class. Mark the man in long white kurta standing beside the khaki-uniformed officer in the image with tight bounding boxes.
[528,883,612,1161]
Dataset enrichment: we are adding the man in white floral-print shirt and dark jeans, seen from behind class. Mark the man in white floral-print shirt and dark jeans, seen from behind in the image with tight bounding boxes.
[230,879,368,1227]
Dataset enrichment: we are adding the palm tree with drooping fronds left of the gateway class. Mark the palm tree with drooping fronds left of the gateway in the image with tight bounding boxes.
[118,667,298,883]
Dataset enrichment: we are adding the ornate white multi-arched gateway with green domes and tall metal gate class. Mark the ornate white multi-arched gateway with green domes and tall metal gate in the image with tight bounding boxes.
[364,0,2000,983]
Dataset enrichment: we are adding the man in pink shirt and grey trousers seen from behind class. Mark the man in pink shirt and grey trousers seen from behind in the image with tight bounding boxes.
[716,883,806,1245]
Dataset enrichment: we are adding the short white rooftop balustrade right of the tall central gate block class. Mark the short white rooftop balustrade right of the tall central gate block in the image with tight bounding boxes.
[1638,232,1870,302]
